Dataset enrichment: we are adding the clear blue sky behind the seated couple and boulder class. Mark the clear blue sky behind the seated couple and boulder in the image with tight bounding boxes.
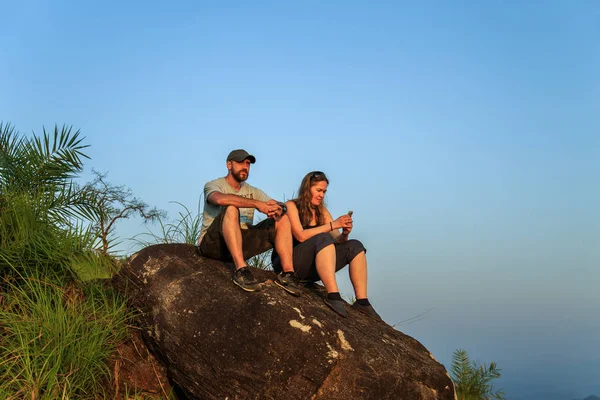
[0,1,600,400]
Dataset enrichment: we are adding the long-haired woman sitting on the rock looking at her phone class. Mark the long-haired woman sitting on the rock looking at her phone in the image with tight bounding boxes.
[273,171,381,319]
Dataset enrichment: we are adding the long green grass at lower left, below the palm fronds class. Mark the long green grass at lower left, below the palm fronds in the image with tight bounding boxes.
[0,270,127,400]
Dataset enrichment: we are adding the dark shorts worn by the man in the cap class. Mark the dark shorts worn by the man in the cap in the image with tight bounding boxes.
[199,210,275,261]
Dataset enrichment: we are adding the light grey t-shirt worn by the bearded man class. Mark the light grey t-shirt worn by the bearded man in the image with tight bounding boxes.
[198,178,271,243]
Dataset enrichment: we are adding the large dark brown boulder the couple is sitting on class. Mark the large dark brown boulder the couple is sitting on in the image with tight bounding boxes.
[116,244,454,400]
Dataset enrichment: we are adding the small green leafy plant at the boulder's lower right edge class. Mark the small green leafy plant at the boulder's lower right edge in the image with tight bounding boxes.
[450,349,505,400]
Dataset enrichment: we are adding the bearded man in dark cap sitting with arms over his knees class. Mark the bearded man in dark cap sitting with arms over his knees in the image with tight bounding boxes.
[197,149,301,296]
